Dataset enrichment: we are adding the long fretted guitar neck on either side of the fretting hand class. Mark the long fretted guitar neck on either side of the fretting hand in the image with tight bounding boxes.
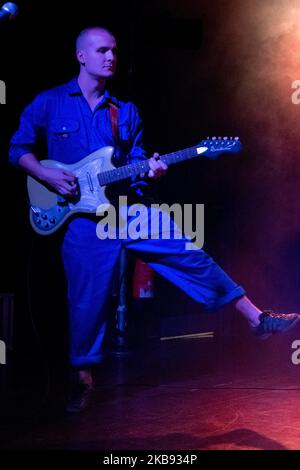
[98,146,204,186]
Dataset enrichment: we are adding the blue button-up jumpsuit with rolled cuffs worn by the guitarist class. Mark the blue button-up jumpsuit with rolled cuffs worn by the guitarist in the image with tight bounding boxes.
[10,78,245,366]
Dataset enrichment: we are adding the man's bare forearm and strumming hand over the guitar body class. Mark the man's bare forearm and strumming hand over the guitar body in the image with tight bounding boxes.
[19,153,78,198]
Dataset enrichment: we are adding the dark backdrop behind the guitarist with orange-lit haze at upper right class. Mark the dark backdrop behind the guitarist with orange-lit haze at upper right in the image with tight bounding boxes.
[0,0,300,370]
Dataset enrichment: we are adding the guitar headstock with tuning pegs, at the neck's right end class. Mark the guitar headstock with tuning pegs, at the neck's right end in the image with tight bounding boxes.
[196,137,242,160]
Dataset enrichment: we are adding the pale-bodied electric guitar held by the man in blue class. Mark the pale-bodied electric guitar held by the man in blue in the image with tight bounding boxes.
[27,137,241,235]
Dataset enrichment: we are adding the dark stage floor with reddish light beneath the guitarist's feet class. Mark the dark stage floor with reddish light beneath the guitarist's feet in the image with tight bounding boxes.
[1,331,300,450]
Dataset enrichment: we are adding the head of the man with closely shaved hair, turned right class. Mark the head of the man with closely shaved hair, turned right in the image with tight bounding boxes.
[77,30,117,79]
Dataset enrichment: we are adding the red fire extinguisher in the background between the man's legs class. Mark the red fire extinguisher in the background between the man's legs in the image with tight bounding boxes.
[132,258,154,299]
